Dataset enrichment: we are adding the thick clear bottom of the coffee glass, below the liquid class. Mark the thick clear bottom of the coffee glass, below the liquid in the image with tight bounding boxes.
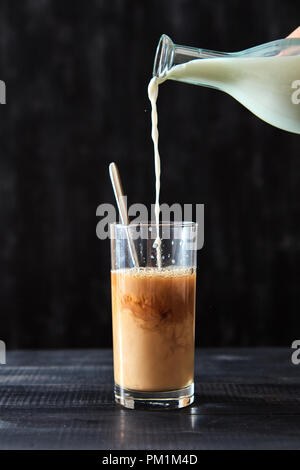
[114,383,194,410]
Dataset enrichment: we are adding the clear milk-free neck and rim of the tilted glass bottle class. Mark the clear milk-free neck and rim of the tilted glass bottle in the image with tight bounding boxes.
[153,34,230,78]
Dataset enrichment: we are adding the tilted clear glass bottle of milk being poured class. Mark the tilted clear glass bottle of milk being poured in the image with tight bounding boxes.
[153,34,300,134]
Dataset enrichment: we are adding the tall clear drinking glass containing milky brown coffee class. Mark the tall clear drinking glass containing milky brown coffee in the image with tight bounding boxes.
[111,222,197,408]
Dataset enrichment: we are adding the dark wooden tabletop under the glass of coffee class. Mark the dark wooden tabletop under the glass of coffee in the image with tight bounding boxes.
[0,349,300,450]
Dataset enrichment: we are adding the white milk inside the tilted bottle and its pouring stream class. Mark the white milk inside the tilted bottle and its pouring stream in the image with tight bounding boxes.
[148,55,300,267]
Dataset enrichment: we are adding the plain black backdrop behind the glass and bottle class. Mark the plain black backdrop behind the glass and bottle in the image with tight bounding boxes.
[0,0,300,348]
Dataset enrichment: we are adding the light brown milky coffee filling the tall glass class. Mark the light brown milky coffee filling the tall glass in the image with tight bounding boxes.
[111,267,196,391]
